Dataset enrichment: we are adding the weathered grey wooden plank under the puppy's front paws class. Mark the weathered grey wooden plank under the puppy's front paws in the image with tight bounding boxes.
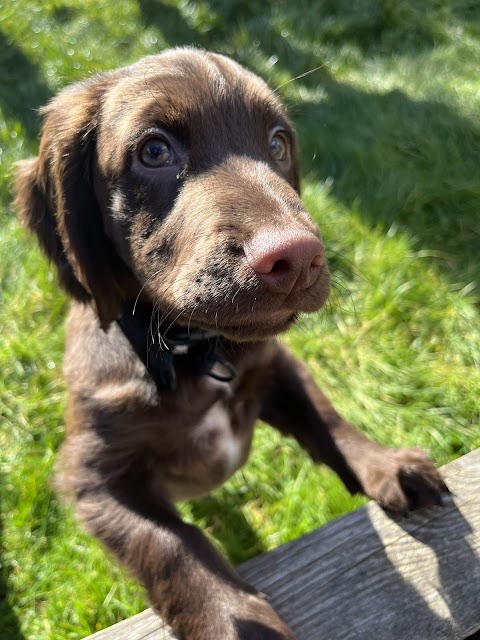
[84,449,480,640]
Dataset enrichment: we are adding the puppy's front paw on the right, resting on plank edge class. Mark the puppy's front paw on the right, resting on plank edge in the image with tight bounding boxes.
[364,449,449,514]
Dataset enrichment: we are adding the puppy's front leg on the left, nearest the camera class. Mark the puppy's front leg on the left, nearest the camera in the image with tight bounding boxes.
[60,433,295,640]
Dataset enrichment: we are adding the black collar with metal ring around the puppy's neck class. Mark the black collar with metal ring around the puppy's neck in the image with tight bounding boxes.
[117,302,236,390]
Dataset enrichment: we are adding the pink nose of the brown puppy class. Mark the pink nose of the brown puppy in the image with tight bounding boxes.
[244,229,325,295]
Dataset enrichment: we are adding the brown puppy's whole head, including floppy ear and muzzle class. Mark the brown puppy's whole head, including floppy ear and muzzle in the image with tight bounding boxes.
[16,49,329,340]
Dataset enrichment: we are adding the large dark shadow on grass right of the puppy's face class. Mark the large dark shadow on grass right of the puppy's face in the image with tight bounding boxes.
[293,73,480,282]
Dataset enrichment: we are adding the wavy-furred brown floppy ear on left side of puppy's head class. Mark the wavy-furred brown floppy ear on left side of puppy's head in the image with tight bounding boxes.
[15,75,126,328]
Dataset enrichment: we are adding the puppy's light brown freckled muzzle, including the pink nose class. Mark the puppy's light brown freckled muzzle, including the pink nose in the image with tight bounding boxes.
[140,157,329,339]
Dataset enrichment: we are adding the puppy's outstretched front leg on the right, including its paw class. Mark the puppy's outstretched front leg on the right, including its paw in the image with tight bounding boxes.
[261,344,448,513]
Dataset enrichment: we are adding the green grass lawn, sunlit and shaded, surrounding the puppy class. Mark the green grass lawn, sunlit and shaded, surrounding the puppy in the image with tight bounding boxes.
[0,0,480,640]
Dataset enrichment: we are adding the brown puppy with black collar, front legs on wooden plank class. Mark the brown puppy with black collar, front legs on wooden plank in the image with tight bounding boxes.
[16,49,447,640]
